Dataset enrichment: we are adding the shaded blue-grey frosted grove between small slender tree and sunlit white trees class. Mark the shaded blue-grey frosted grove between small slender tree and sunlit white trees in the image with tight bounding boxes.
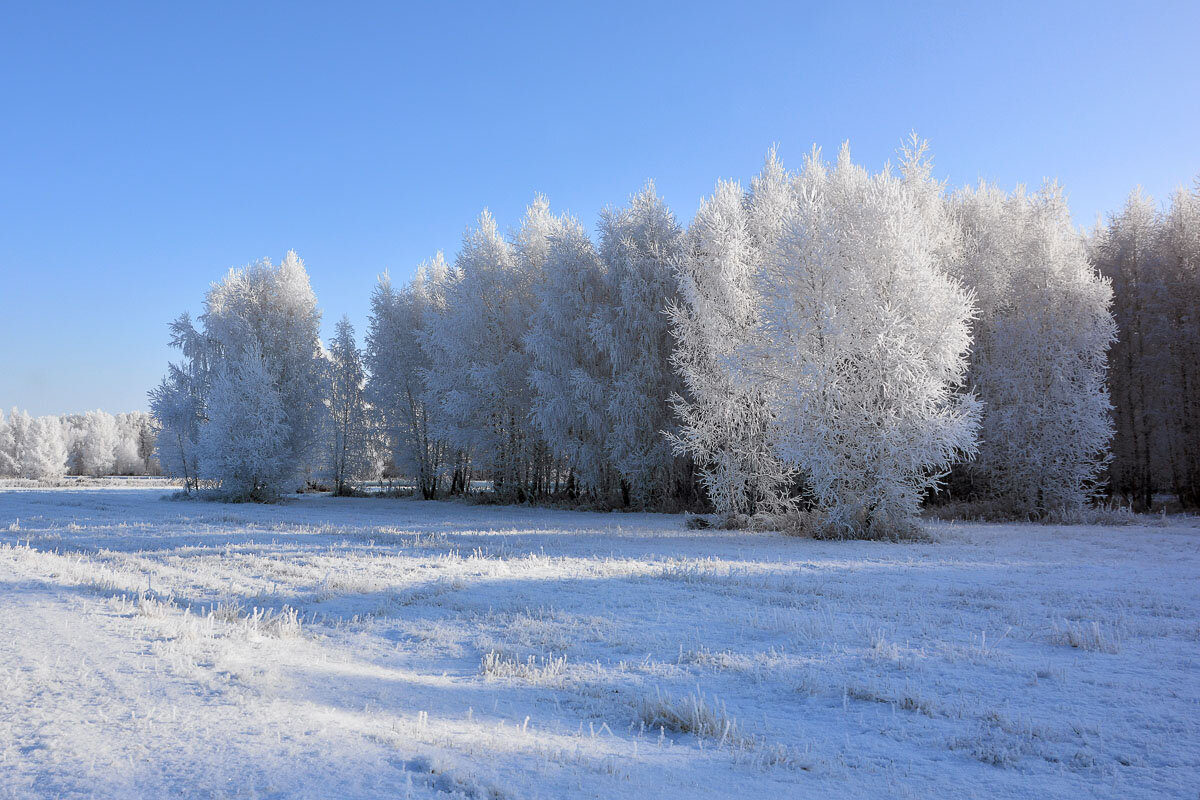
[366,190,697,507]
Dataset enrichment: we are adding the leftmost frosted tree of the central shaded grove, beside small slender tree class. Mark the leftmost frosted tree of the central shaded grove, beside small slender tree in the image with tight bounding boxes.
[366,260,449,500]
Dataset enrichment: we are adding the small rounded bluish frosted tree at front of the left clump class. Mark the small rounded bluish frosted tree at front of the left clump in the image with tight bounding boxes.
[198,339,294,501]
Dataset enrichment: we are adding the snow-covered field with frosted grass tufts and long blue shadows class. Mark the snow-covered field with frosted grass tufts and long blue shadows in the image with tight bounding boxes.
[0,488,1200,799]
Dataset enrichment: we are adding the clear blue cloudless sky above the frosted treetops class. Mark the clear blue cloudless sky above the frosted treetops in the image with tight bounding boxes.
[0,0,1200,414]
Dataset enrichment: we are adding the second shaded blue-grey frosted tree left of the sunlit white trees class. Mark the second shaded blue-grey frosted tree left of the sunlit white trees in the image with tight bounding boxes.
[526,219,613,497]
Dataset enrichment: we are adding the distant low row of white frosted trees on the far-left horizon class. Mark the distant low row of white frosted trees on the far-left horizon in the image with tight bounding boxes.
[0,408,158,480]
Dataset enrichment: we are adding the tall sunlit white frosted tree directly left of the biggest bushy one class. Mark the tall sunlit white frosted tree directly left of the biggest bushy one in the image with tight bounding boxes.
[670,163,796,515]
